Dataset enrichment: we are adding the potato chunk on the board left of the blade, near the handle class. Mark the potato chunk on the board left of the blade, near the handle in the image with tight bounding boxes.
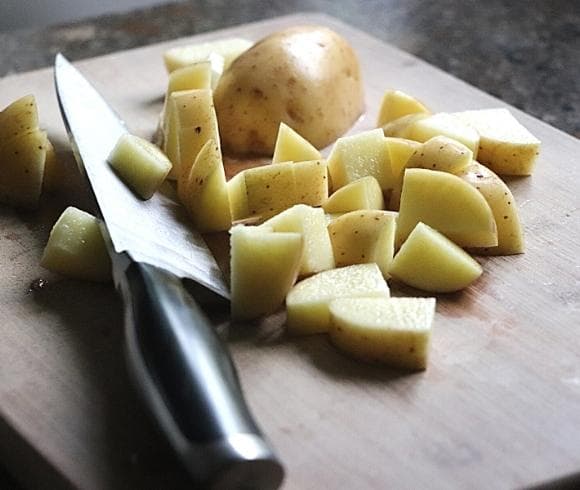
[40,207,111,282]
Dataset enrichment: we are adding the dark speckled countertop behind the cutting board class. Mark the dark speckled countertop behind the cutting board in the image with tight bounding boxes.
[0,0,580,488]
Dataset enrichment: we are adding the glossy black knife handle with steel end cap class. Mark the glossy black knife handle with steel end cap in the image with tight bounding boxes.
[116,261,284,490]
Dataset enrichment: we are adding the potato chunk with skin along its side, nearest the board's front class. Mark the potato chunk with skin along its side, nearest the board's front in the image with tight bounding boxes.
[329,298,435,370]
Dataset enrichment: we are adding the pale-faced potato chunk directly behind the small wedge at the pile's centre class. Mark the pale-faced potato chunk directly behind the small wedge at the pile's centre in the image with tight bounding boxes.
[328,129,393,191]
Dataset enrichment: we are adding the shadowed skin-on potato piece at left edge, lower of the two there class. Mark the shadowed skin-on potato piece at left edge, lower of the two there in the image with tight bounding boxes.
[0,130,48,209]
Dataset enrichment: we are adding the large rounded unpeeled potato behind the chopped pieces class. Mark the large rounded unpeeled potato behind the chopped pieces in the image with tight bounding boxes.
[214,26,364,155]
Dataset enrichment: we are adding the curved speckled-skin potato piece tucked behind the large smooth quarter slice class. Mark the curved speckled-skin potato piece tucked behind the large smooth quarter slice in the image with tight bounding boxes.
[458,162,524,255]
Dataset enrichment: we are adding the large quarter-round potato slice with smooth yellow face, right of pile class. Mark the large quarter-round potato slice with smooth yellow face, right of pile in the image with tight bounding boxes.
[396,168,497,247]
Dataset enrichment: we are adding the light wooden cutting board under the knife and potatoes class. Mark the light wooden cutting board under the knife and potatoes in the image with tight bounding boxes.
[0,14,580,489]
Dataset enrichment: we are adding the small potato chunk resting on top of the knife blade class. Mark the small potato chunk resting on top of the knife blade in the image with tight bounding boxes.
[108,133,171,199]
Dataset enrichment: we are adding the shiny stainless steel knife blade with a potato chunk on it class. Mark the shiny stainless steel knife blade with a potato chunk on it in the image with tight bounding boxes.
[55,54,229,298]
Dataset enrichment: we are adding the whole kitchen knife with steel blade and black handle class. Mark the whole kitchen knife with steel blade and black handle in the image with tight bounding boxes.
[54,54,284,489]
